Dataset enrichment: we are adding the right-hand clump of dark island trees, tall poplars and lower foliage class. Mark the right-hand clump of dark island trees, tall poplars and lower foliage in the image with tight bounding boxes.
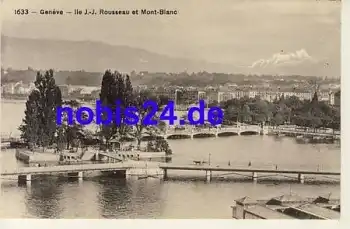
[100,70,173,152]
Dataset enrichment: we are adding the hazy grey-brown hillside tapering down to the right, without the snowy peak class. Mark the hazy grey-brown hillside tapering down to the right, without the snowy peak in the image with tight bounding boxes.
[1,36,230,72]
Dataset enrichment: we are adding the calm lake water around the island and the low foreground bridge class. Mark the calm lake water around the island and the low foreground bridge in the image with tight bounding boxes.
[0,100,340,218]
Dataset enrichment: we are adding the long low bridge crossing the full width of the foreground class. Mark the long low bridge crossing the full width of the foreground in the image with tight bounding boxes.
[0,160,340,183]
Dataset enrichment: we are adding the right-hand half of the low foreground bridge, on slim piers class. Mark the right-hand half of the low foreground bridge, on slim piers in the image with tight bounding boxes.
[159,164,340,183]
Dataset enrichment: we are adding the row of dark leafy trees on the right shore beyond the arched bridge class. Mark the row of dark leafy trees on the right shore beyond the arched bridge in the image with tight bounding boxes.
[219,92,340,129]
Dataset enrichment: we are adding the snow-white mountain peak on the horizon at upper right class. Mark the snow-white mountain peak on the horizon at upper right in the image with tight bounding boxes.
[250,49,316,68]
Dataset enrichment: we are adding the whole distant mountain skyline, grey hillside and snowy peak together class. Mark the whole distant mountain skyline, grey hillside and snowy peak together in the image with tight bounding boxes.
[1,36,340,77]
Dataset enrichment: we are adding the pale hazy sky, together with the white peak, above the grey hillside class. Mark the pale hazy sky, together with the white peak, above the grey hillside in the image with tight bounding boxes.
[1,0,341,75]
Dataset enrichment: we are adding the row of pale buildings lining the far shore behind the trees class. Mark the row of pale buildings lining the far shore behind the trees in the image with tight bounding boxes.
[1,82,340,105]
